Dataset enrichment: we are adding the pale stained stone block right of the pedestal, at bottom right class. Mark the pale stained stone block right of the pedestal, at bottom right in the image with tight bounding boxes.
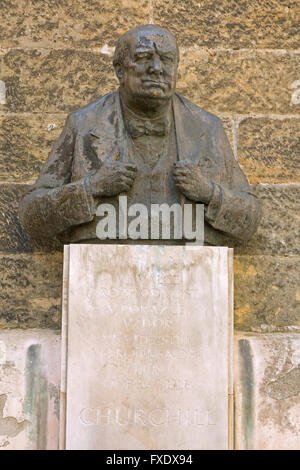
[235,333,300,450]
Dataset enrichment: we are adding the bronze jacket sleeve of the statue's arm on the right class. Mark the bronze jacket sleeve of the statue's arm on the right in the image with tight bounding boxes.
[205,121,261,240]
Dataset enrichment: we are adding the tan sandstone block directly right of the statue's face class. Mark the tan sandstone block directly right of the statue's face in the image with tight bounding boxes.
[178,49,300,114]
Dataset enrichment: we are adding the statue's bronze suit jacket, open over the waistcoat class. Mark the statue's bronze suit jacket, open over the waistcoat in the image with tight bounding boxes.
[19,91,260,245]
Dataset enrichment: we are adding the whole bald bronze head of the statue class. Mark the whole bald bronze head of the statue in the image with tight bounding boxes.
[113,24,179,112]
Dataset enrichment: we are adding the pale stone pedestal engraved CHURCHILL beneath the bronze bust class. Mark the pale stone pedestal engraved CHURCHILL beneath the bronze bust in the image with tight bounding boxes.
[60,245,233,450]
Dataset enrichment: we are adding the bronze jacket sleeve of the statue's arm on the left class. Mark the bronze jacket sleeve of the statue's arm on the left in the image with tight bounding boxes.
[19,114,95,238]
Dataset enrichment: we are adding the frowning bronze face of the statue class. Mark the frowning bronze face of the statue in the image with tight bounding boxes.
[120,30,178,101]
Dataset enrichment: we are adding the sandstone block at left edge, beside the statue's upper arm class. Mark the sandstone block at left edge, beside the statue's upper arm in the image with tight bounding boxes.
[0,114,66,182]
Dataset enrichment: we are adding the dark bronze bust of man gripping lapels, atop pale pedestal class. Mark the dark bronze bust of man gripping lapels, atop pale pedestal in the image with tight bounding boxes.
[20,25,260,245]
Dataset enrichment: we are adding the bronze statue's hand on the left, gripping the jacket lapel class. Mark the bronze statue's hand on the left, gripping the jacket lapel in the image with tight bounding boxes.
[90,158,137,196]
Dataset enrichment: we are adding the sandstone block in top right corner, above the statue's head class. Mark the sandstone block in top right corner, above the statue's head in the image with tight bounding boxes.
[153,0,300,49]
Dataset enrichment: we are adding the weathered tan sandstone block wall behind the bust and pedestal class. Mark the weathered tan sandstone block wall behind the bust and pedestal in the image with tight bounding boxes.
[0,0,300,449]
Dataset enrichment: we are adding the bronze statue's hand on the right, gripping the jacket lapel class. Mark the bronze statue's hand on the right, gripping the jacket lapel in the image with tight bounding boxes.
[174,160,213,204]
